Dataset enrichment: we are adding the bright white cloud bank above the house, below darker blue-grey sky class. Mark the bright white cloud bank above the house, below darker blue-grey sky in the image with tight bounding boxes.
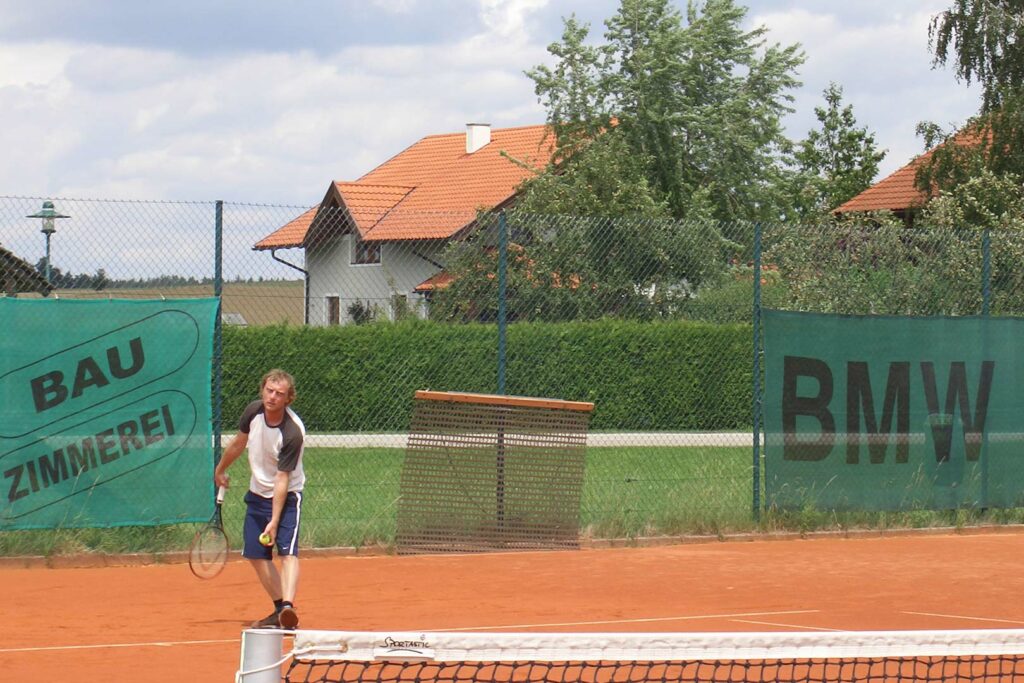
[0,0,561,203]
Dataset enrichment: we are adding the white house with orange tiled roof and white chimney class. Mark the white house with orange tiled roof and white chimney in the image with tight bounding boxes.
[260,123,554,325]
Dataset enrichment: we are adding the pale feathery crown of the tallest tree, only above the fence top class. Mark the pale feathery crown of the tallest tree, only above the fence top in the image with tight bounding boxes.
[527,0,803,220]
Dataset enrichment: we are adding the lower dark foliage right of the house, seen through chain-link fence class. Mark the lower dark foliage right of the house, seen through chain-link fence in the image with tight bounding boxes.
[430,209,737,322]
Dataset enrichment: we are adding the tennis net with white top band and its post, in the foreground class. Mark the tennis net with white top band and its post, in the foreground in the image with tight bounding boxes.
[238,630,1024,683]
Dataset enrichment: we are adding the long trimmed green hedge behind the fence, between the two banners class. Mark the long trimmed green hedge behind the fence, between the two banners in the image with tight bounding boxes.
[222,319,752,432]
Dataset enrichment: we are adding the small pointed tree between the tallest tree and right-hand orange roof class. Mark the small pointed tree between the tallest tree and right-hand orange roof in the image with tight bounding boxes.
[793,83,886,217]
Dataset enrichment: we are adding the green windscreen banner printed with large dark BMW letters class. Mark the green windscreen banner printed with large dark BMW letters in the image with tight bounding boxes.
[764,311,1024,510]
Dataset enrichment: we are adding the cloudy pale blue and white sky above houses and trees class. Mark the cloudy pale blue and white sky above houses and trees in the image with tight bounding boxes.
[0,0,979,206]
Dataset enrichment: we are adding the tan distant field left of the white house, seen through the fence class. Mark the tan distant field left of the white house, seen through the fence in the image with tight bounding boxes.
[48,280,303,326]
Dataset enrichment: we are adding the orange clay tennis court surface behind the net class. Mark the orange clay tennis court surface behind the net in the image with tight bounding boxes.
[0,528,1024,683]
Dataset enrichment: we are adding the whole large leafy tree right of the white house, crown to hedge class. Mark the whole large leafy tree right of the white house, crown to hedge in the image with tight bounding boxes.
[431,0,803,321]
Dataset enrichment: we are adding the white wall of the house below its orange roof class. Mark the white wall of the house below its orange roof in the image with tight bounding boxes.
[306,236,443,326]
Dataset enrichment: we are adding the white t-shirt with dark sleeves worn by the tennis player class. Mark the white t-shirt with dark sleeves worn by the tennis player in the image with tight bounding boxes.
[239,400,306,498]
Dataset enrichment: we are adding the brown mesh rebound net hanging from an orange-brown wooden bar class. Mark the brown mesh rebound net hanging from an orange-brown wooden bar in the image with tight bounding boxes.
[395,391,594,554]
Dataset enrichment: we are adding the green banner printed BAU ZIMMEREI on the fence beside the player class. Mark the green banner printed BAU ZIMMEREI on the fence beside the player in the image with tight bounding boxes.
[0,298,217,529]
